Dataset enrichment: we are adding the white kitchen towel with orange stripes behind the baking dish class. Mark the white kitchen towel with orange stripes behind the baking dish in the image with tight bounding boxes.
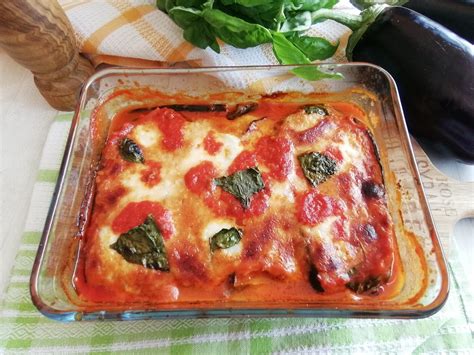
[59,0,357,67]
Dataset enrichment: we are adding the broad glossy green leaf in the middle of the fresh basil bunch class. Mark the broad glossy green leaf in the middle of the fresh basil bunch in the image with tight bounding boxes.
[203,9,272,48]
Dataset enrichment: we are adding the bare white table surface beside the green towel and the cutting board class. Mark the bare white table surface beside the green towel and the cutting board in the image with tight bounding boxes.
[0,49,474,300]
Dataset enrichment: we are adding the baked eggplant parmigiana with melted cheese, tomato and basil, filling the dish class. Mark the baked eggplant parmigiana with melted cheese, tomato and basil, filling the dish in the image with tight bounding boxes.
[75,97,400,304]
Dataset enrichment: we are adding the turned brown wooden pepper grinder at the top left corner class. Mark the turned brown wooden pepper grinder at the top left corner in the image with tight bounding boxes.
[0,0,94,111]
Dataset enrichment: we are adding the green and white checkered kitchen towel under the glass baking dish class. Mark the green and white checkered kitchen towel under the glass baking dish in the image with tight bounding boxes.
[0,114,474,354]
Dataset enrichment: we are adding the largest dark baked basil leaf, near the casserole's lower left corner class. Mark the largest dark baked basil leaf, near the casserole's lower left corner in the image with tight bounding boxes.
[110,215,169,271]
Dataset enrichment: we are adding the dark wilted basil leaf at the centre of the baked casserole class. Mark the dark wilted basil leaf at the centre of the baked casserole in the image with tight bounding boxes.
[214,167,265,208]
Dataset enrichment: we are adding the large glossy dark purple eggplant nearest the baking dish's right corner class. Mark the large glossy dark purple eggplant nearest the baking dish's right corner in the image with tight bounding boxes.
[350,7,474,164]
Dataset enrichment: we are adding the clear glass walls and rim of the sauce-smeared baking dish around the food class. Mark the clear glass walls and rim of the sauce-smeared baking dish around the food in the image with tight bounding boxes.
[30,63,448,321]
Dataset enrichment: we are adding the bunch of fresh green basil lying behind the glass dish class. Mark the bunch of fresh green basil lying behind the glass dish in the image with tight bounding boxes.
[157,0,346,80]
